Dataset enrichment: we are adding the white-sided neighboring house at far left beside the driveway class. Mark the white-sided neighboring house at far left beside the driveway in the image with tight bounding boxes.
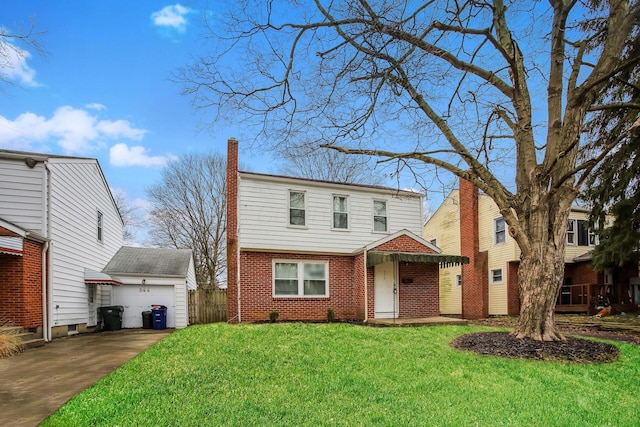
[0,150,123,340]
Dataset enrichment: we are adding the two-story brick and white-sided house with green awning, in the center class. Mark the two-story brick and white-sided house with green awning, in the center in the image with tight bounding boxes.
[227,138,464,322]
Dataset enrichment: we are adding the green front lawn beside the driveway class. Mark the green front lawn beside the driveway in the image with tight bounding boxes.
[42,323,640,426]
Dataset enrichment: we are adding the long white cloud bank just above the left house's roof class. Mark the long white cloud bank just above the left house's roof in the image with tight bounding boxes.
[0,105,147,155]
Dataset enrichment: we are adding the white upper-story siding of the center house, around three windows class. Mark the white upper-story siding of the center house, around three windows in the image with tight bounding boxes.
[238,173,422,254]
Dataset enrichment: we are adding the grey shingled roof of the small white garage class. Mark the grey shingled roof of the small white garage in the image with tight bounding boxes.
[102,246,191,277]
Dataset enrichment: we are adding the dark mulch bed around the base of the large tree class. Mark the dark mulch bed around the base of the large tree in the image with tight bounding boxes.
[451,332,620,363]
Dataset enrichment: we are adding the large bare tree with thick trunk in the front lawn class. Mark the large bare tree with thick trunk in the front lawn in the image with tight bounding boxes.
[181,0,640,340]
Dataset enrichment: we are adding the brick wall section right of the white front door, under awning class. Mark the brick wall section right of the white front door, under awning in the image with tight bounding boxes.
[398,262,440,319]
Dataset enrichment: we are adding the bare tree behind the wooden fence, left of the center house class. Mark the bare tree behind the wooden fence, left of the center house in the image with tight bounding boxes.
[147,154,227,289]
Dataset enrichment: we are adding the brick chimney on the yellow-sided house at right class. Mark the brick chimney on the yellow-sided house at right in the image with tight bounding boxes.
[459,178,489,319]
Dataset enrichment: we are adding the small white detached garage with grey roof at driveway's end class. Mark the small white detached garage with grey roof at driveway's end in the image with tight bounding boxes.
[102,246,196,328]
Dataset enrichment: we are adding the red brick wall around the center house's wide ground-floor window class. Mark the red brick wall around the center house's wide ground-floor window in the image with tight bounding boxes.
[240,251,362,322]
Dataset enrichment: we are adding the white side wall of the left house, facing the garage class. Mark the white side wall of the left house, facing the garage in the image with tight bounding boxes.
[49,158,122,327]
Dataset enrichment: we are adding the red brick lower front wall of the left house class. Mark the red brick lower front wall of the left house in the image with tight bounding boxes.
[0,234,42,328]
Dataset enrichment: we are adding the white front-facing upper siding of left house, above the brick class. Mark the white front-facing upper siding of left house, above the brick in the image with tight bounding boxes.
[0,159,46,236]
